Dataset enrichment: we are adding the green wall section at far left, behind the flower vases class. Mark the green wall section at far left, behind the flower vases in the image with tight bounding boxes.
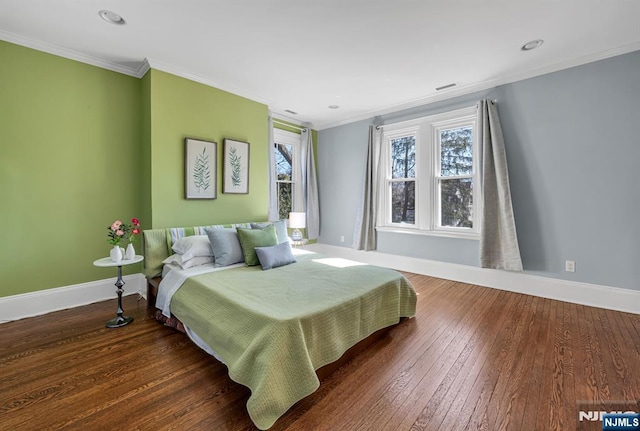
[0,41,146,296]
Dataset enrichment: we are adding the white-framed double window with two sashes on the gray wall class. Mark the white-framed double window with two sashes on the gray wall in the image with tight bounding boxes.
[377,107,481,238]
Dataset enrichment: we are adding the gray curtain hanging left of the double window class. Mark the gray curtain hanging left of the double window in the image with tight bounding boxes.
[352,126,382,251]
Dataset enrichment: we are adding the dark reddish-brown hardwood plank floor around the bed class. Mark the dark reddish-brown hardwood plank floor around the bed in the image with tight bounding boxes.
[0,274,640,431]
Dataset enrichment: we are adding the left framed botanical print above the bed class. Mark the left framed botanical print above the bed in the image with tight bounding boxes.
[184,138,218,199]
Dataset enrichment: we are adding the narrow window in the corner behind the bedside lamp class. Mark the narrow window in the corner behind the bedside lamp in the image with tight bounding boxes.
[273,129,301,220]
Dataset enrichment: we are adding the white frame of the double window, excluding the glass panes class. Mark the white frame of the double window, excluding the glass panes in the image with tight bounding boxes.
[376,106,482,239]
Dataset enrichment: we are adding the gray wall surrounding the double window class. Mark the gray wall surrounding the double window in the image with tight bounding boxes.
[318,51,640,290]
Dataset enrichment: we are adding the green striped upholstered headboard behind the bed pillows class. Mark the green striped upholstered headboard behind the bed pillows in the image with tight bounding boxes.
[142,222,264,278]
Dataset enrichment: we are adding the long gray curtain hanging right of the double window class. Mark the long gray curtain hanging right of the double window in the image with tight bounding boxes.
[478,100,522,271]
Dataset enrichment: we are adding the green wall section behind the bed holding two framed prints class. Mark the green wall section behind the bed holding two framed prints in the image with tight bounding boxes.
[145,69,268,228]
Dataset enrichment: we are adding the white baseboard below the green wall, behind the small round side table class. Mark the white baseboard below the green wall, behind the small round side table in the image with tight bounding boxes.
[0,274,147,323]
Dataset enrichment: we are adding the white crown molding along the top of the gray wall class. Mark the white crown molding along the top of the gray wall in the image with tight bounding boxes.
[317,42,640,130]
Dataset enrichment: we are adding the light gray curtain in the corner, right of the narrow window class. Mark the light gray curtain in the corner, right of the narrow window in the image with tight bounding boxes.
[300,125,320,239]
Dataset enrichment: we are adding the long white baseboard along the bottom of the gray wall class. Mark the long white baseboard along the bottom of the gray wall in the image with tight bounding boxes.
[306,244,640,314]
